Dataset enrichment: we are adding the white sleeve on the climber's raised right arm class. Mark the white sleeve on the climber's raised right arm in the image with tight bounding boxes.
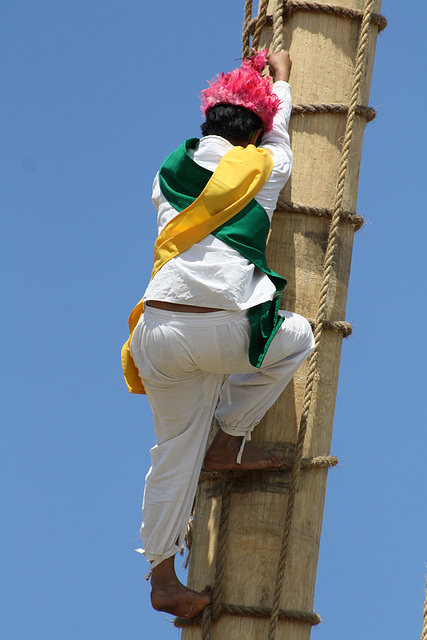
[256,80,292,218]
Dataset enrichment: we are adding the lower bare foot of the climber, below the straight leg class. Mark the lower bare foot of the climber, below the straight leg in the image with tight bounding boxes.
[151,557,212,618]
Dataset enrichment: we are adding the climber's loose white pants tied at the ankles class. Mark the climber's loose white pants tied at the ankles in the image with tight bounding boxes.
[131,307,314,568]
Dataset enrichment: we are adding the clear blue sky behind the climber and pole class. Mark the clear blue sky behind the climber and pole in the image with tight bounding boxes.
[0,0,427,640]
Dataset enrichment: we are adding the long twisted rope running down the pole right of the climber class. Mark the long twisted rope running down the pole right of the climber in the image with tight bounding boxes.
[268,0,373,640]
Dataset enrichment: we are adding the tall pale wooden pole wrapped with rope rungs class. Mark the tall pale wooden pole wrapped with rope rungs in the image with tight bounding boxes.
[182,0,381,640]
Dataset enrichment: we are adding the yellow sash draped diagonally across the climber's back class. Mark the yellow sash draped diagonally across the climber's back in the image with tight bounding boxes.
[122,145,273,393]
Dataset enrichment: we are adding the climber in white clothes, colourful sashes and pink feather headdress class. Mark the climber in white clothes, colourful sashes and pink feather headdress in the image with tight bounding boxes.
[122,51,314,618]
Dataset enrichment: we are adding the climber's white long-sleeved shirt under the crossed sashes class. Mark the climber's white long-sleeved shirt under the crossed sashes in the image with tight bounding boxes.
[144,80,292,311]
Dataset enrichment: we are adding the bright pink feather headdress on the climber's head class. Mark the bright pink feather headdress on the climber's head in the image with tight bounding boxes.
[201,49,280,133]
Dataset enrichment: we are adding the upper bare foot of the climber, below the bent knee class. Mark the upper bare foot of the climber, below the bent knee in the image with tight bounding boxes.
[203,429,283,471]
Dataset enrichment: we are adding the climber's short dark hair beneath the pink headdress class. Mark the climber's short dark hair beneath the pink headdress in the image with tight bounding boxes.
[201,104,262,142]
